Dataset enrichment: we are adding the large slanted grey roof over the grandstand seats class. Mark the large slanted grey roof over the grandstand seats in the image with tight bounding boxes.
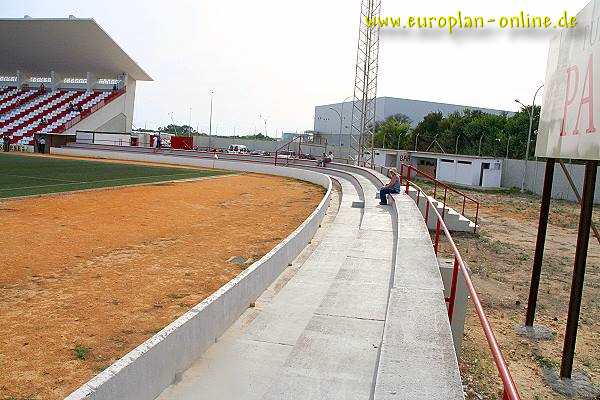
[0,18,152,81]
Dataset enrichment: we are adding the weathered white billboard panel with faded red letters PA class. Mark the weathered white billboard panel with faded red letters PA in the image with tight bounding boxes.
[535,0,600,160]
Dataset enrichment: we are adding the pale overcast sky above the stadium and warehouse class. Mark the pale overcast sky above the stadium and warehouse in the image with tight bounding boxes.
[0,0,587,137]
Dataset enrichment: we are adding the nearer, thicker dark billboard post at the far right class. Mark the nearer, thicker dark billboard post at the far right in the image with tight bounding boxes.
[560,160,598,378]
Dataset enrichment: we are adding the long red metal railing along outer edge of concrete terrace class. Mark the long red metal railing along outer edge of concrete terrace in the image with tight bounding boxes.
[405,169,521,400]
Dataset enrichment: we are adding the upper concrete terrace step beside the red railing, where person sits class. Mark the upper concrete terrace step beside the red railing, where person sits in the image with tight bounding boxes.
[374,193,464,400]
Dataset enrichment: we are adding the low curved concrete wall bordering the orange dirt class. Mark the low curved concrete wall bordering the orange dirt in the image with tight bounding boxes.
[52,148,331,400]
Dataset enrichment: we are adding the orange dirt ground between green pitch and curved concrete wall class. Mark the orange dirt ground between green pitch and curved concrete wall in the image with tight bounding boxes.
[0,174,323,399]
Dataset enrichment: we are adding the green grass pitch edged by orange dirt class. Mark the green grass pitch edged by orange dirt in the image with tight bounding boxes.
[0,153,228,198]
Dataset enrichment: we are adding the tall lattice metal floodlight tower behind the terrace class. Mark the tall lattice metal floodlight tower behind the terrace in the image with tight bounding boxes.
[350,0,381,166]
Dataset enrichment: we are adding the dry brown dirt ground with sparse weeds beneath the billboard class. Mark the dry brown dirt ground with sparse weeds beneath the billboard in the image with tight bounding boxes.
[432,186,600,399]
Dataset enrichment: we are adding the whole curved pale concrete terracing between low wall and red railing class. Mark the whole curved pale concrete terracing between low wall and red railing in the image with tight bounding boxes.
[158,163,464,400]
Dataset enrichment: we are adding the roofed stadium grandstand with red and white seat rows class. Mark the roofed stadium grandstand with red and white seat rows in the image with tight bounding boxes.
[0,16,152,151]
